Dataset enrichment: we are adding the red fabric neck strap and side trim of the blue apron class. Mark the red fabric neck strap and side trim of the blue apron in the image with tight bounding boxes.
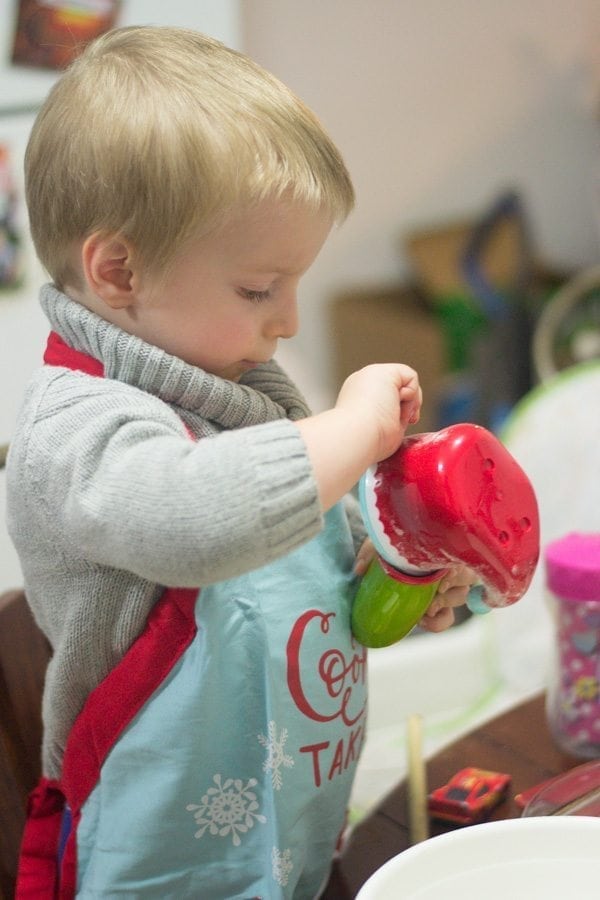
[15,332,198,900]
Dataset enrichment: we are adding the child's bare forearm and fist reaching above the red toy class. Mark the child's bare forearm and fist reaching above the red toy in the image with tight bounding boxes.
[298,363,422,510]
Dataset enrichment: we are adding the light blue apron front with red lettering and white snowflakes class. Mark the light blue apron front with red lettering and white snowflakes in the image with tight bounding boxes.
[77,506,366,900]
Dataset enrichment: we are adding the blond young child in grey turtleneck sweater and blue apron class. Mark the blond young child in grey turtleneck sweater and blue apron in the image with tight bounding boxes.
[8,27,470,900]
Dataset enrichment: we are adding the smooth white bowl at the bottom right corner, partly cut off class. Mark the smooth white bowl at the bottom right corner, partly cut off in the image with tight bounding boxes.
[356,816,600,900]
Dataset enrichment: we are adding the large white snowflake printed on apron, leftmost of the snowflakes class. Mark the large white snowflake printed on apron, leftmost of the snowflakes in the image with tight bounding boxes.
[186,775,267,847]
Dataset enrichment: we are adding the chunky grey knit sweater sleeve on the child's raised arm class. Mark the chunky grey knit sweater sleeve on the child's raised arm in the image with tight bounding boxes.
[9,373,322,587]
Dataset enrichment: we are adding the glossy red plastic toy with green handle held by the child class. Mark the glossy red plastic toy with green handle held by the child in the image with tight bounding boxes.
[352,423,540,647]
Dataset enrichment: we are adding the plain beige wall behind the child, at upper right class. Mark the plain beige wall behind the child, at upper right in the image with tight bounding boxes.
[242,0,600,400]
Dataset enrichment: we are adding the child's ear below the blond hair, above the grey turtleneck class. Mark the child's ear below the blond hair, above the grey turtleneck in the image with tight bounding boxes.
[81,233,139,309]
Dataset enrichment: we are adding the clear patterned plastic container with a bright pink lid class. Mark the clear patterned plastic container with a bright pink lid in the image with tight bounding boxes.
[545,533,600,759]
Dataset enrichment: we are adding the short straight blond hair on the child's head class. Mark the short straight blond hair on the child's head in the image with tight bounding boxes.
[25,27,354,287]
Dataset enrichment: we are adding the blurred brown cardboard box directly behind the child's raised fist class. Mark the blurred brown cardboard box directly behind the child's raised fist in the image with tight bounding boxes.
[330,286,446,432]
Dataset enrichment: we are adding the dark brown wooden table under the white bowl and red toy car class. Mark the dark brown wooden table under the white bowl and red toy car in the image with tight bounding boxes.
[323,695,583,900]
